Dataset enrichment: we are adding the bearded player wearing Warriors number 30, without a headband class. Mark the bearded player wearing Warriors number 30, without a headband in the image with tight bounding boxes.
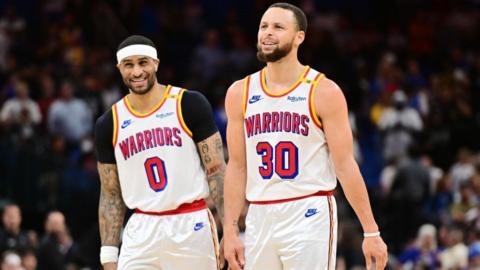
[224,3,387,270]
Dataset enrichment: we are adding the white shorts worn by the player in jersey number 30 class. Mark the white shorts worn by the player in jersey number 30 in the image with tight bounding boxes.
[245,194,337,270]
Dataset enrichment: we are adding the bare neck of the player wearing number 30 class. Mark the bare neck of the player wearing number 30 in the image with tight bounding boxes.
[265,56,305,91]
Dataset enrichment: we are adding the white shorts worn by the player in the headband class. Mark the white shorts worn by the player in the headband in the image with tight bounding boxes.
[118,201,219,270]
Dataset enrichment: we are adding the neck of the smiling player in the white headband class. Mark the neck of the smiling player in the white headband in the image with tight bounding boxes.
[127,82,166,113]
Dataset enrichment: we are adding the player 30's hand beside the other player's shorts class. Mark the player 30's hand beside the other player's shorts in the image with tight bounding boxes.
[223,228,245,270]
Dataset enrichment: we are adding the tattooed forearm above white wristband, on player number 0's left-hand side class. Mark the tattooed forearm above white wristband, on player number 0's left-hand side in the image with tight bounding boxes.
[98,163,126,246]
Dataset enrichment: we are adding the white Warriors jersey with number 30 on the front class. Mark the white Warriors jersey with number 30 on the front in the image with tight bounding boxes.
[243,67,337,201]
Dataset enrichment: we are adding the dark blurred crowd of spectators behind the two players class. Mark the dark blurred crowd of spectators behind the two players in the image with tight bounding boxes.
[0,0,480,270]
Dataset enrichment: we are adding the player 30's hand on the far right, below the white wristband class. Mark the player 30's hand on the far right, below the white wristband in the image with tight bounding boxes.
[362,236,388,270]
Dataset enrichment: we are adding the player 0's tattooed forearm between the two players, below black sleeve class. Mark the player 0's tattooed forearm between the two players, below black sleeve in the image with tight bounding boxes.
[197,131,229,220]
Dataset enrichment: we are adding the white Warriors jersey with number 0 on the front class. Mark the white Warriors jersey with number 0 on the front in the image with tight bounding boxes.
[112,86,208,211]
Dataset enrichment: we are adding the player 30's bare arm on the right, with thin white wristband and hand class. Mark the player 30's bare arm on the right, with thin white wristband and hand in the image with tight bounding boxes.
[315,79,387,270]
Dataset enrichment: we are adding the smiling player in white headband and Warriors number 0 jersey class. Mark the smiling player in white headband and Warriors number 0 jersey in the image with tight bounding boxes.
[95,35,225,270]
